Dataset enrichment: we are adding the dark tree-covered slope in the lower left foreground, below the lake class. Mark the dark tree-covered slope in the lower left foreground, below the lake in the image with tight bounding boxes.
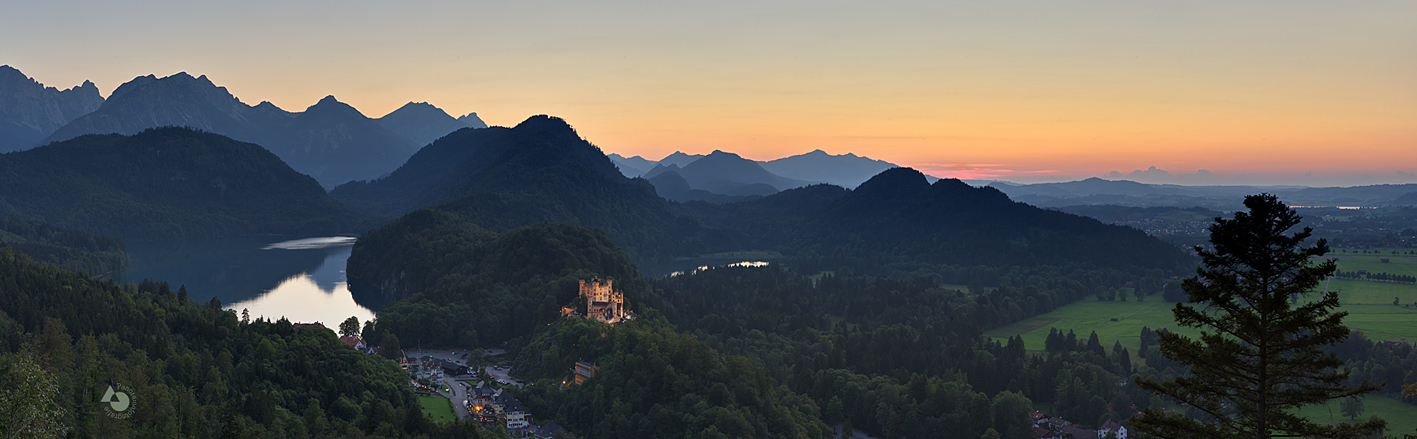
[0,246,501,438]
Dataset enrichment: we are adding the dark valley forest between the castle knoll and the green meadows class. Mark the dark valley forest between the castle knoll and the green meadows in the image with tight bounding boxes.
[645,261,1175,439]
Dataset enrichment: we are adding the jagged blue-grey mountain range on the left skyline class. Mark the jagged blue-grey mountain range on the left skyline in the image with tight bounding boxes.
[0,67,486,188]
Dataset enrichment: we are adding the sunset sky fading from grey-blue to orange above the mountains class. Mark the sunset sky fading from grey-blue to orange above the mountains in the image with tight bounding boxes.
[0,0,1417,186]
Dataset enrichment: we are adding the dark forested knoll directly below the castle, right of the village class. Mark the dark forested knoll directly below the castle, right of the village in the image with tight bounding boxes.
[514,313,830,438]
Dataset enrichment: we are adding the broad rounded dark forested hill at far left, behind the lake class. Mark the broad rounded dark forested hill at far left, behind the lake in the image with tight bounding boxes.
[0,127,367,239]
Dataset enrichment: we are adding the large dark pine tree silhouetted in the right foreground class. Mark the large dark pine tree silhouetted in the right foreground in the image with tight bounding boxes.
[1134,194,1386,439]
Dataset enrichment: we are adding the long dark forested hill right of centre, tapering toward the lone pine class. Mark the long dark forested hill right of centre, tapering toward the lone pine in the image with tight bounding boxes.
[689,169,1190,272]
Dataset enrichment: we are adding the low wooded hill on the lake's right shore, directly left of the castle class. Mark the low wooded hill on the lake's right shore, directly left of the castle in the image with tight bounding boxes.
[349,222,649,346]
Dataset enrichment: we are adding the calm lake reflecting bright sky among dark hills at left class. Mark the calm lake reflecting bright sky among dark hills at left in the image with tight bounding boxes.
[118,236,374,329]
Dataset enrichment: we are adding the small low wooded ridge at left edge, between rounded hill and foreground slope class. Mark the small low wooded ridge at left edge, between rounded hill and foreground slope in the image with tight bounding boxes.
[0,218,128,275]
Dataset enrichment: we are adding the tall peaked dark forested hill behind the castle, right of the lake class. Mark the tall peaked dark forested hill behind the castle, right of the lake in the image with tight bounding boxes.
[332,116,733,266]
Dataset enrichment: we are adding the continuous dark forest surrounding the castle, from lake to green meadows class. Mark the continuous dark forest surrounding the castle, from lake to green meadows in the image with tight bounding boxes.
[350,216,1161,439]
